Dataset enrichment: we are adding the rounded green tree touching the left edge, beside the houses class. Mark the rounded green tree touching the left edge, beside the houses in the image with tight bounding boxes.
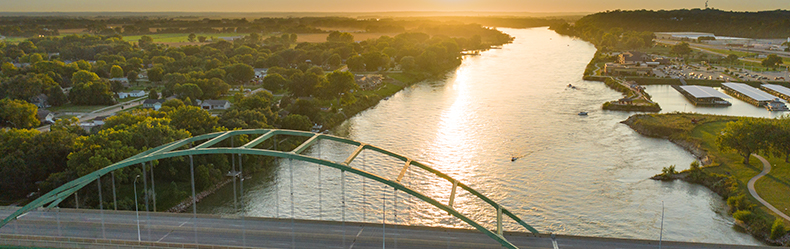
[0,99,40,129]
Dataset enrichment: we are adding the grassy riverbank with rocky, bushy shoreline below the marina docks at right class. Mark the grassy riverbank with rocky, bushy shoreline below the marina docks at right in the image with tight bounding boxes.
[622,113,790,245]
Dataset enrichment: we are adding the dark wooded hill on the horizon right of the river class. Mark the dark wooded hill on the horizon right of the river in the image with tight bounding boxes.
[556,9,790,39]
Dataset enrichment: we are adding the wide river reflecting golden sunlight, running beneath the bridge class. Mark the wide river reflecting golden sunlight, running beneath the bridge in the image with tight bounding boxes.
[198,28,760,245]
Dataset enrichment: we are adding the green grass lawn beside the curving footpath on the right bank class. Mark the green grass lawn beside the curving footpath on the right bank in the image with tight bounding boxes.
[639,114,790,225]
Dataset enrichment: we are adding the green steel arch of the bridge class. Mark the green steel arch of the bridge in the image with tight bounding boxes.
[0,129,538,248]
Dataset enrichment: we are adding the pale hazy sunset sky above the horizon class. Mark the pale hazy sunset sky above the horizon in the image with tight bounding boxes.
[0,0,790,12]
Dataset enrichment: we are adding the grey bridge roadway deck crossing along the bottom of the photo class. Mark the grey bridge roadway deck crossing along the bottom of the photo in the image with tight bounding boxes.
[0,209,772,249]
